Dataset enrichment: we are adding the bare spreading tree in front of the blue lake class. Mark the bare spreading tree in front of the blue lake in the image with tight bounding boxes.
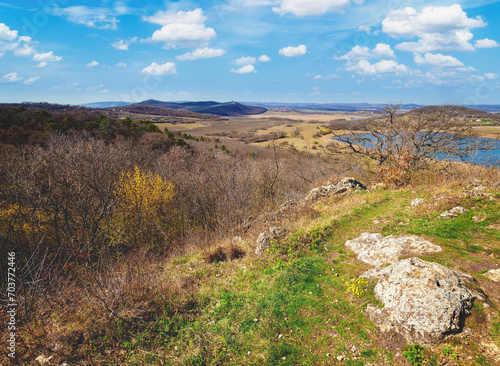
[335,105,491,184]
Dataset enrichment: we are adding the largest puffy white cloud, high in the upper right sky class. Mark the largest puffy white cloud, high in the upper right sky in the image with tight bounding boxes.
[382,4,486,53]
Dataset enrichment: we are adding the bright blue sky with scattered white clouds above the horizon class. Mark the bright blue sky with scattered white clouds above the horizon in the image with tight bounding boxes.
[0,0,500,104]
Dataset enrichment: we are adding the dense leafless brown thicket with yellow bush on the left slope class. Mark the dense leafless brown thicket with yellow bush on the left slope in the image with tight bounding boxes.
[0,116,331,321]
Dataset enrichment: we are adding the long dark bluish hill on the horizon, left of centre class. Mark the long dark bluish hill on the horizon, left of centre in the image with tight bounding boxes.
[135,99,267,117]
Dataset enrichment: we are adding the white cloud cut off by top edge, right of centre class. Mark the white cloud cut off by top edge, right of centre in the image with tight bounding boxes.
[273,0,352,17]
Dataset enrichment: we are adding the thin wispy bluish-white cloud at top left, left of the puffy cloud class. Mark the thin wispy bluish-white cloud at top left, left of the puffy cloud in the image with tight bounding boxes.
[54,5,119,29]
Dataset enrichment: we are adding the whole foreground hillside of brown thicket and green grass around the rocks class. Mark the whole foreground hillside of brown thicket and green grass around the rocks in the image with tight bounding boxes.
[0,104,500,366]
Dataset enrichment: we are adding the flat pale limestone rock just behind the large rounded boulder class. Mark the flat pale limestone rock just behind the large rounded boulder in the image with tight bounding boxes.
[345,233,442,267]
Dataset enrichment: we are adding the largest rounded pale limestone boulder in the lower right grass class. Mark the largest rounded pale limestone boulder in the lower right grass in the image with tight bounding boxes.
[361,258,481,344]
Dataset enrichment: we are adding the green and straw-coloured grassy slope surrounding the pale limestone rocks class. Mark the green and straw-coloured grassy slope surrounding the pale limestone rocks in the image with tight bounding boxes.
[62,182,500,366]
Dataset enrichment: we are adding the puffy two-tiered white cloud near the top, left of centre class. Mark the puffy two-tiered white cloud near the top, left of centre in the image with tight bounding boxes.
[143,9,217,48]
